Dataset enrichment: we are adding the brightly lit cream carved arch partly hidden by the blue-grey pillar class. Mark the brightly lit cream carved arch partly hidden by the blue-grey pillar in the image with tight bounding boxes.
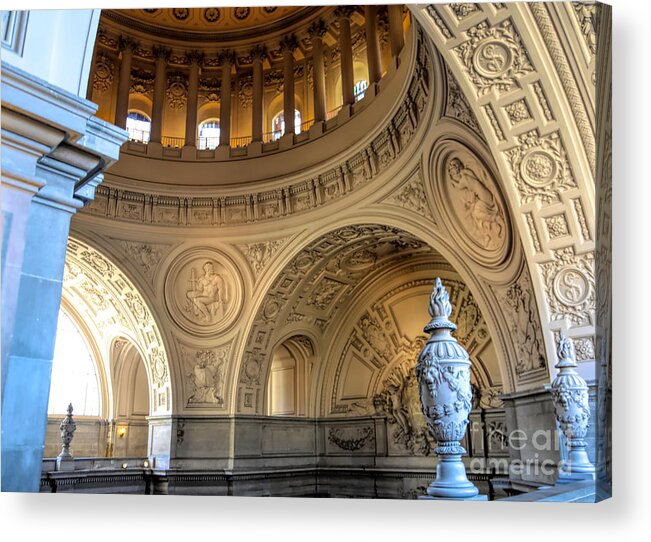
[63,237,172,415]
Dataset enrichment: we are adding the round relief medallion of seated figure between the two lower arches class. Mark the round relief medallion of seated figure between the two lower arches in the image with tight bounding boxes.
[165,249,243,335]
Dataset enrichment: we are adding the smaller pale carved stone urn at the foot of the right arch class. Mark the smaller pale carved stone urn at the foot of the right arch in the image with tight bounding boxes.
[550,331,595,478]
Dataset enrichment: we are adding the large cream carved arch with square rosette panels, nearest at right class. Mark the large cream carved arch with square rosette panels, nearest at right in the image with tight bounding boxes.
[410,2,601,386]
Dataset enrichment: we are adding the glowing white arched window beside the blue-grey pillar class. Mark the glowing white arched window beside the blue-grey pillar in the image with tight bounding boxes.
[47,311,100,416]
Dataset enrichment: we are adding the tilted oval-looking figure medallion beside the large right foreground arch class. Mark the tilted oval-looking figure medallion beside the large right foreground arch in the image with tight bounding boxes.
[433,142,510,265]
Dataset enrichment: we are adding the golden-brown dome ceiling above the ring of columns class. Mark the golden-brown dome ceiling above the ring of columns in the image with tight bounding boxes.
[103,6,327,41]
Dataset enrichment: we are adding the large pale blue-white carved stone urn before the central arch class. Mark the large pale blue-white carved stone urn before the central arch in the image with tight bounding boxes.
[416,278,479,499]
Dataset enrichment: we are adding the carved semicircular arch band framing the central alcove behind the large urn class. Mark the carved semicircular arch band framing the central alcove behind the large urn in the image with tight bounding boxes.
[233,215,536,413]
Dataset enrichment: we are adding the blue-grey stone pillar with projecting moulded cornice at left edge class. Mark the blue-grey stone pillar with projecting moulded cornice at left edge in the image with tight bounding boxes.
[2,65,126,492]
